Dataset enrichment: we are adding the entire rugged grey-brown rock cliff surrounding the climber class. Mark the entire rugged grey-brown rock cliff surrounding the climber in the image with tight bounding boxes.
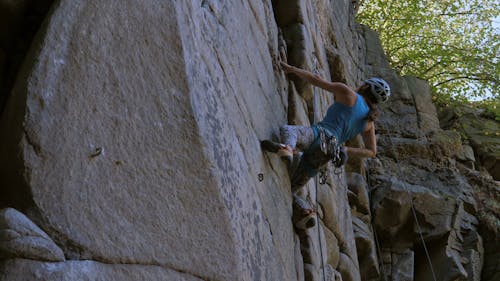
[0,0,498,281]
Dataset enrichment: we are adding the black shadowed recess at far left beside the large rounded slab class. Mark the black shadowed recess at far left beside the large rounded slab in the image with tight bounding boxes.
[0,0,54,211]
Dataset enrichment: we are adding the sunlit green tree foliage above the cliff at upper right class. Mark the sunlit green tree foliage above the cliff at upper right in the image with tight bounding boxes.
[358,0,500,117]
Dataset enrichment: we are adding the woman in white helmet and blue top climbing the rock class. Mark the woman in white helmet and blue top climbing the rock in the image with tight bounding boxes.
[261,62,391,228]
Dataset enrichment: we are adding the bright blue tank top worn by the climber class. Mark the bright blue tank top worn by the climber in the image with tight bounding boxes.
[318,93,370,144]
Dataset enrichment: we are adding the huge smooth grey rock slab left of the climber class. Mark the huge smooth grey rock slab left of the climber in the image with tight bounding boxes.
[0,1,296,280]
